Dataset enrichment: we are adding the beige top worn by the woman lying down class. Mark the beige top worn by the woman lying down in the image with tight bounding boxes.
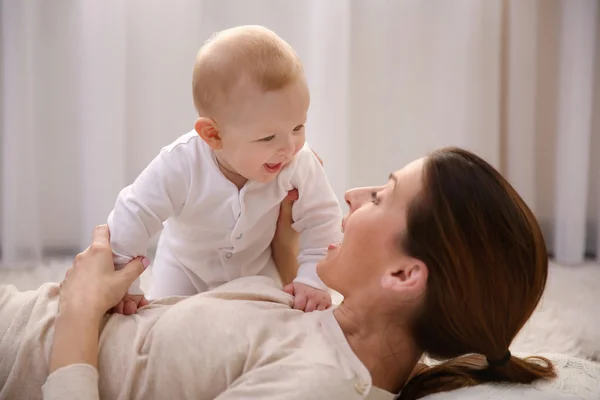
[0,276,394,400]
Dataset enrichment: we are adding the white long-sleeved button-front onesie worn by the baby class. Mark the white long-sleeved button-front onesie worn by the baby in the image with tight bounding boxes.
[108,131,342,298]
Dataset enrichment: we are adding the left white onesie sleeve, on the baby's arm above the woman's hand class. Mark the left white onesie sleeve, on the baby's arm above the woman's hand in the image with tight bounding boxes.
[108,145,191,294]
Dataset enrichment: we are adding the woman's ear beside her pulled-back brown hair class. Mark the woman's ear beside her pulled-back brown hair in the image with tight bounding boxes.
[381,258,428,292]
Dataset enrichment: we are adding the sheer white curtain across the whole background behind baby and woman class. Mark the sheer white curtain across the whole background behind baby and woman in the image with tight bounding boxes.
[0,0,600,267]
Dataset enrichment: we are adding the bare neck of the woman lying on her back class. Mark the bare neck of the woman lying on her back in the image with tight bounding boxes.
[334,300,423,393]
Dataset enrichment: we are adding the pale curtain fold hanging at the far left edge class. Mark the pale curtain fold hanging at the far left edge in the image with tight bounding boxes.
[1,1,42,264]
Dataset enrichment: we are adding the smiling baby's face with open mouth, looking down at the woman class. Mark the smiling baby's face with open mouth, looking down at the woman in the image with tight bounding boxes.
[219,80,310,182]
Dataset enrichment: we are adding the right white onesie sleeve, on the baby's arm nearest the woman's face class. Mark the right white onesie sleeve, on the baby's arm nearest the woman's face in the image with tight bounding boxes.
[292,151,342,289]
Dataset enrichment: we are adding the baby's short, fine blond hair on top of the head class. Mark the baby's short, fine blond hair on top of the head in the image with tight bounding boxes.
[192,25,304,117]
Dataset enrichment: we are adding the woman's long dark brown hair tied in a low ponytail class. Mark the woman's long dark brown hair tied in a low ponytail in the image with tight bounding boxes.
[398,148,555,400]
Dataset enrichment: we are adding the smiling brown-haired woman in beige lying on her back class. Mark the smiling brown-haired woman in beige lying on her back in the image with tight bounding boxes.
[0,148,555,400]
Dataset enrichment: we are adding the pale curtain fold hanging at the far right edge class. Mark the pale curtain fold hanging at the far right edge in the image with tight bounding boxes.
[554,0,598,263]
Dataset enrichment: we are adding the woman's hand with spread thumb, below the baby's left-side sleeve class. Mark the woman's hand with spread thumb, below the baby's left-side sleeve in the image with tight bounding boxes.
[59,225,150,320]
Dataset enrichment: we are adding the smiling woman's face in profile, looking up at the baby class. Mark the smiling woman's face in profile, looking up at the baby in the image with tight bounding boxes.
[317,159,424,295]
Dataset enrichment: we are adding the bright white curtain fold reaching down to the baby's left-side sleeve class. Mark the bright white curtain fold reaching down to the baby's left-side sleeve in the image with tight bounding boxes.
[74,1,127,248]
